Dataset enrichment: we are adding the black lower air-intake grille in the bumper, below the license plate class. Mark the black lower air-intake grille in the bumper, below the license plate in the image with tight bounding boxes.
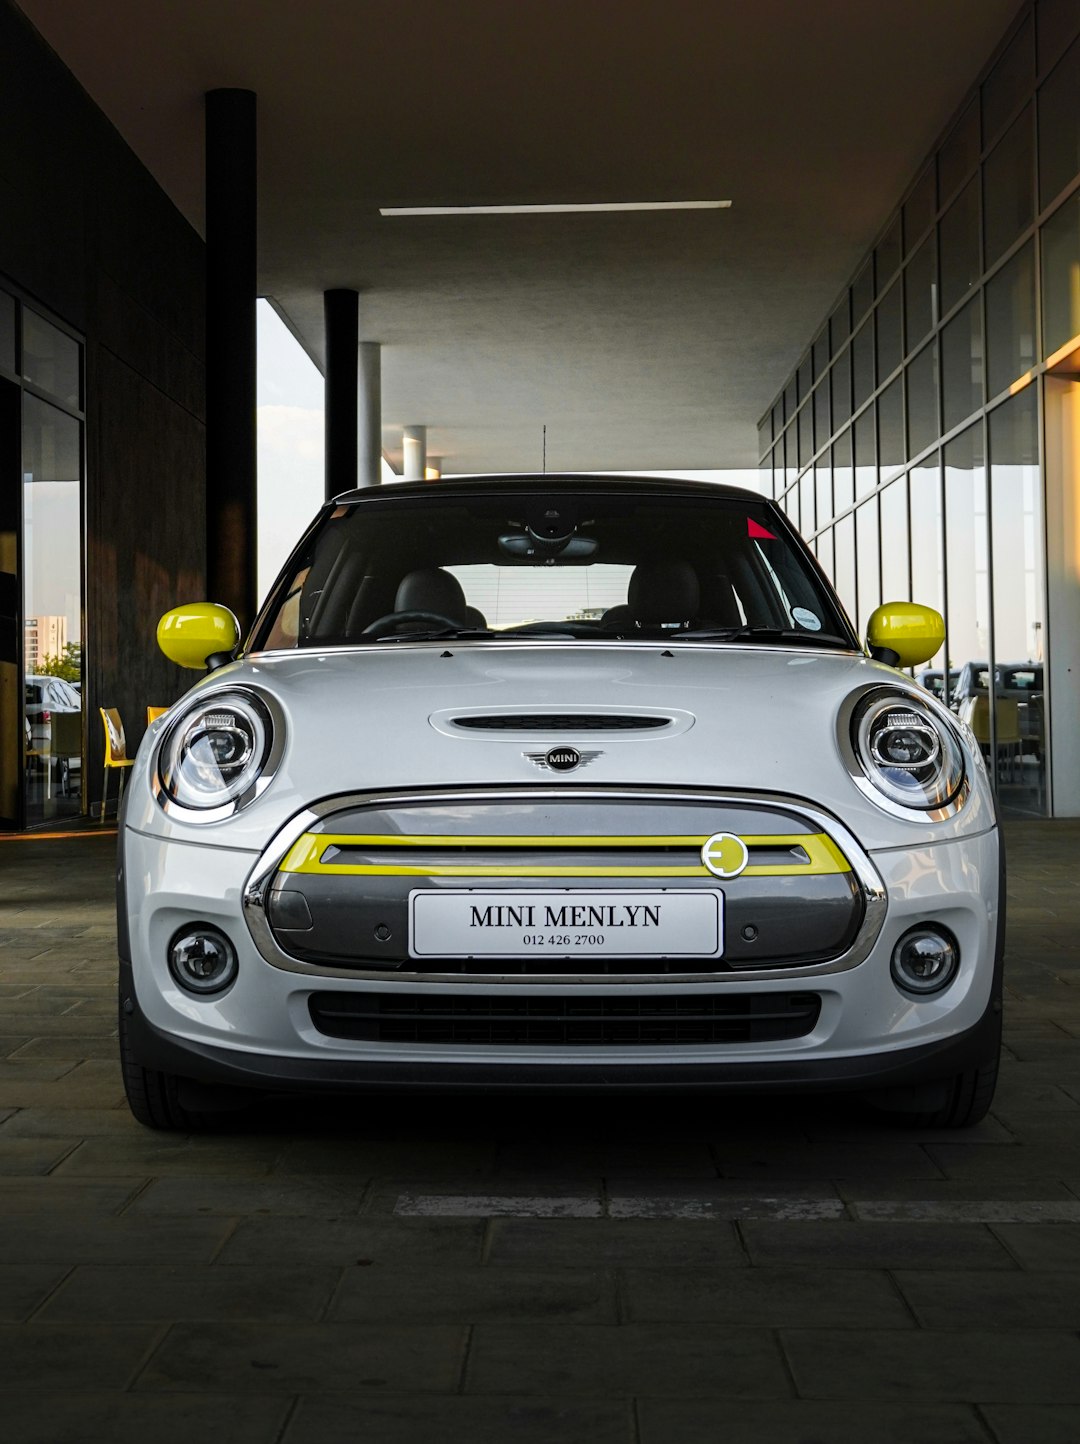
[309,992,822,1047]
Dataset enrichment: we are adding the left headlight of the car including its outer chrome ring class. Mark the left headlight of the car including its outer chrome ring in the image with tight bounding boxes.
[152,686,284,825]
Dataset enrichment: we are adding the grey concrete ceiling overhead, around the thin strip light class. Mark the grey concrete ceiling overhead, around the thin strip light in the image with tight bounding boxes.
[19,0,1018,472]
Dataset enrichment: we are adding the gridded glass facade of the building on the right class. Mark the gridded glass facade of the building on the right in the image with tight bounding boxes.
[762,0,1080,817]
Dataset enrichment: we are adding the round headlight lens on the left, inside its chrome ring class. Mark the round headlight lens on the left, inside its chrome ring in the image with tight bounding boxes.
[157,692,273,812]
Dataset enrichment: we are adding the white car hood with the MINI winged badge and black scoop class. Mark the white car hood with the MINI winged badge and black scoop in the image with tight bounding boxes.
[127,641,993,851]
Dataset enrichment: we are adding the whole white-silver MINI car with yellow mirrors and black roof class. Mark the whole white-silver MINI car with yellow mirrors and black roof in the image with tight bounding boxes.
[118,477,1002,1129]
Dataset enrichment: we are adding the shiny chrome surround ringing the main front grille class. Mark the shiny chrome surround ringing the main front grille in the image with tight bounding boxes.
[243,787,887,988]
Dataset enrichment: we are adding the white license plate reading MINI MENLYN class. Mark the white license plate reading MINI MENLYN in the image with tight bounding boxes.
[409,888,723,957]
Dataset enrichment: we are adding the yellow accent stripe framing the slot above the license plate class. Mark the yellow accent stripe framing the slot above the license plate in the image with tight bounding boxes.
[280,832,850,881]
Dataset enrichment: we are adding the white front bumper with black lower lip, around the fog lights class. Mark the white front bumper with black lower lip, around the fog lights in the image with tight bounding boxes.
[120,791,1003,1092]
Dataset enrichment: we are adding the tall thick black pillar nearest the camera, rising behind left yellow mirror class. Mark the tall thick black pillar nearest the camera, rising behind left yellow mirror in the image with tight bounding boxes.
[206,90,258,631]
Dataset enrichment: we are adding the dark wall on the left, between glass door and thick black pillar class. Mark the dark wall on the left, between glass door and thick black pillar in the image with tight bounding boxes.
[0,0,205,800]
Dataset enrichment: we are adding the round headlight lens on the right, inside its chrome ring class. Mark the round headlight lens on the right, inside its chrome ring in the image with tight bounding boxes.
[852,693,964,812]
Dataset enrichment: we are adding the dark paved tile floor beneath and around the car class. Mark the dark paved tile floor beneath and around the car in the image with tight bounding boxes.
[0,823,1080,1444]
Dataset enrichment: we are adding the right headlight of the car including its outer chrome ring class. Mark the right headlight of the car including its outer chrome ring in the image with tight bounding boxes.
[837,686,972,822]
